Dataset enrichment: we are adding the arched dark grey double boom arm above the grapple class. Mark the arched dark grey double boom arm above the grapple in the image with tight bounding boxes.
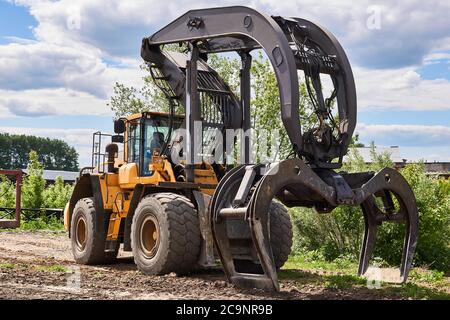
[141,6,356,166]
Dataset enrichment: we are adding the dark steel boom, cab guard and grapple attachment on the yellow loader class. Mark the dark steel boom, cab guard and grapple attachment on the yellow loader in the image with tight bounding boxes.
[141,6,418,290]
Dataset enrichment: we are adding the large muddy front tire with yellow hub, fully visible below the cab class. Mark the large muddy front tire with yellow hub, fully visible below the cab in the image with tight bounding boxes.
[131,193,201,275]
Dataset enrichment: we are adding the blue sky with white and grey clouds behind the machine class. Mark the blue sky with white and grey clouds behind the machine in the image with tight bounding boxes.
[0,0,450,165]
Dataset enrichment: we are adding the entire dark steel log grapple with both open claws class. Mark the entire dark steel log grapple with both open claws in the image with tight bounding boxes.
[211,158,418,290]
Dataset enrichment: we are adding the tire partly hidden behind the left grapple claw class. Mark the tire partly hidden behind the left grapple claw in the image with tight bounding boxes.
[234,201,293,273]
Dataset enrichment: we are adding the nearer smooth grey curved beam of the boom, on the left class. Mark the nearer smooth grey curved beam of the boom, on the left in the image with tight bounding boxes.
[141,6,302,149]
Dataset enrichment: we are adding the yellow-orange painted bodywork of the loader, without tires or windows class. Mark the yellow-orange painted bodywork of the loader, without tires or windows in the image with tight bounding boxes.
[64,112,218,245]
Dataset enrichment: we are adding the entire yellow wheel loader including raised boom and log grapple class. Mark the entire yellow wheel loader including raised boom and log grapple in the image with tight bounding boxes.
[64,6,418,290]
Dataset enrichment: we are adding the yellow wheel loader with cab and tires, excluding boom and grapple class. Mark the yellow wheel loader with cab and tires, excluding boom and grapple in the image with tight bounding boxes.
[64,112,292,274]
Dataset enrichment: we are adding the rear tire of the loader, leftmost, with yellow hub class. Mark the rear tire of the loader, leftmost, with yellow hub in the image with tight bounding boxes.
[70,198,119,264]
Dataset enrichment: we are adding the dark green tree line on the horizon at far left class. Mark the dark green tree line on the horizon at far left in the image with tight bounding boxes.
[0,133,78,171]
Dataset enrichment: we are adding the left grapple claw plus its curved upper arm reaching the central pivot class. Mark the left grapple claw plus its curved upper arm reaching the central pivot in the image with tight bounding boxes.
[211,158,334,291]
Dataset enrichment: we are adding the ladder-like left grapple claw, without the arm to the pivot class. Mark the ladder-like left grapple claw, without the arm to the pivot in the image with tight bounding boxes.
[210,165,279,290]
